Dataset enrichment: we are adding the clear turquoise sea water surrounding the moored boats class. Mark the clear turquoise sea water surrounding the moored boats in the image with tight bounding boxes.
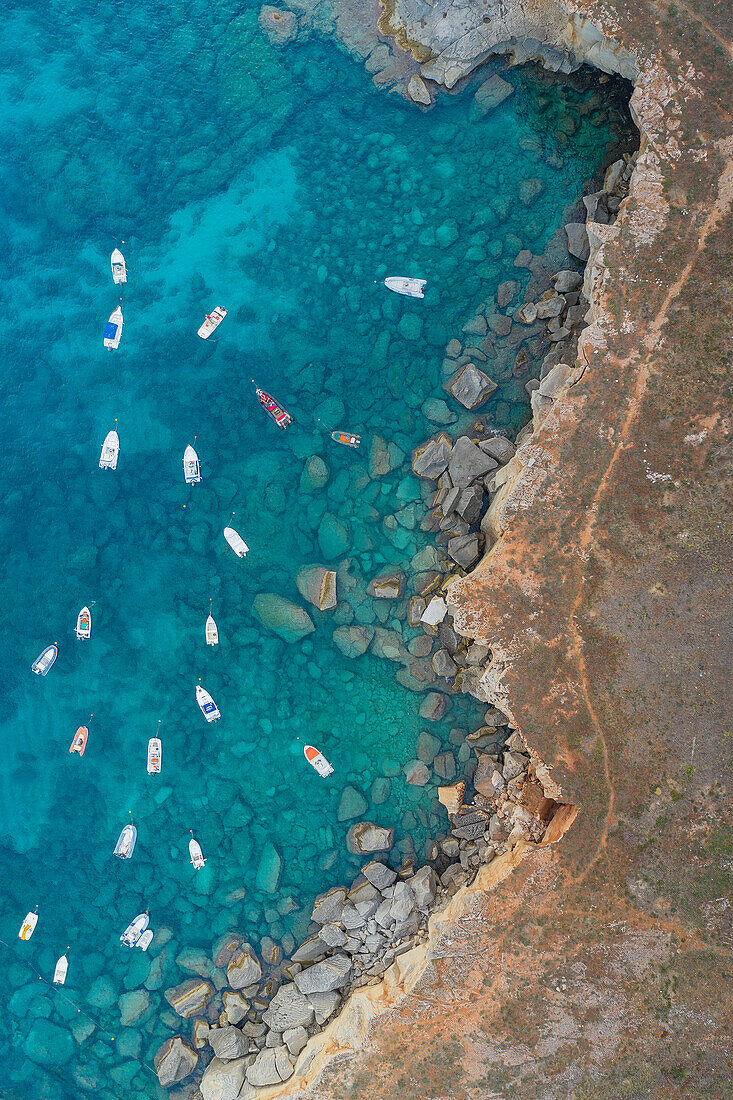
[0,0,629,1100]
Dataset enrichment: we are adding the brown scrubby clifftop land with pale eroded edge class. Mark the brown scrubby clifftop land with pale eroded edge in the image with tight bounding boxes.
[249,0,733,1098]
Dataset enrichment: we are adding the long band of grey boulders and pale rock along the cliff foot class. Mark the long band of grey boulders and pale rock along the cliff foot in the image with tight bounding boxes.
[150,36,636,1100]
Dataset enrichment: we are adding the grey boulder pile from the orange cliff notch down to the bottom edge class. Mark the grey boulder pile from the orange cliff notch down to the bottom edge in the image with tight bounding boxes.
[154,726,555,1100]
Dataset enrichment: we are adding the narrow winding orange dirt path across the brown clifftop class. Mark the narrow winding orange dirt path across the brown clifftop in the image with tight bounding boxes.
[570,146,733,883]
